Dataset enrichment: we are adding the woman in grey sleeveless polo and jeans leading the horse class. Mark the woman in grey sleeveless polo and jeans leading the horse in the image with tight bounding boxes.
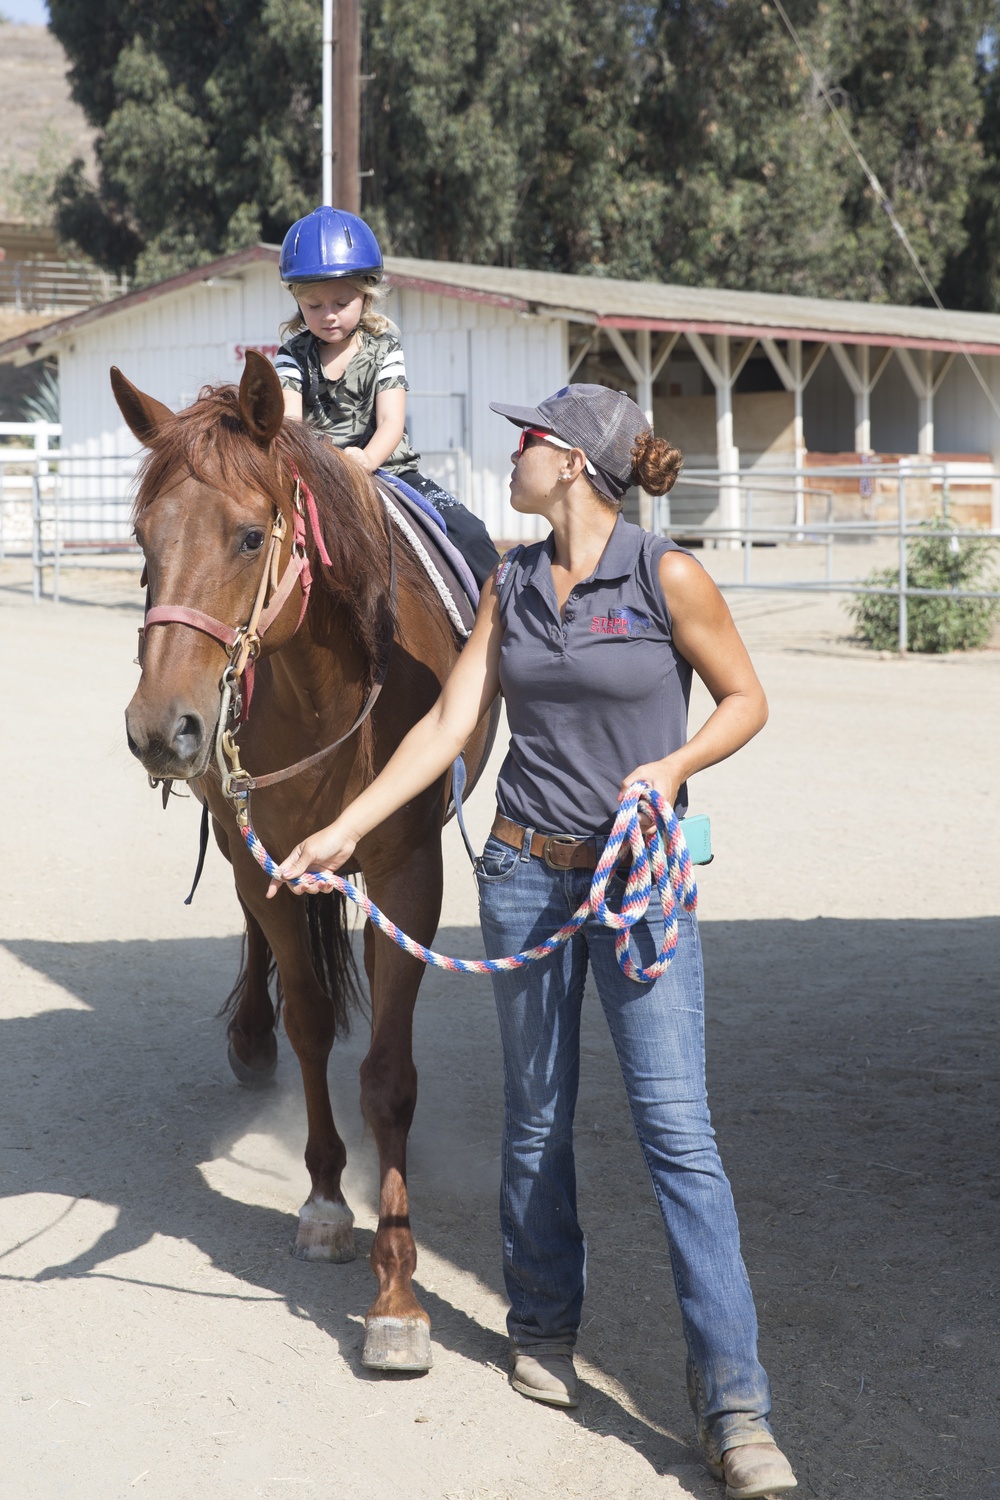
[271,386,796,1500]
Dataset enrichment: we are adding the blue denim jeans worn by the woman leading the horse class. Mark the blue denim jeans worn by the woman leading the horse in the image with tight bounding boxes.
[477,837,771,1460]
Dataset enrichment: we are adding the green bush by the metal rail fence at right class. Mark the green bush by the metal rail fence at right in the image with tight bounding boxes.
[846,516,1000,651]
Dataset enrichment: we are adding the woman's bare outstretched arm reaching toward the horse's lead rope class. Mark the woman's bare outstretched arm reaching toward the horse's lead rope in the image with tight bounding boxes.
[267,578,502,897]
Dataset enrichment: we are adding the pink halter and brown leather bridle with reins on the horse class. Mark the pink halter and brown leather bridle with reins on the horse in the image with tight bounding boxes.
[138,464,396,822]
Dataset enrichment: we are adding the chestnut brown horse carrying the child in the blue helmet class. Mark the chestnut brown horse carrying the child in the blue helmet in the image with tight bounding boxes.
[111,353,497,1370]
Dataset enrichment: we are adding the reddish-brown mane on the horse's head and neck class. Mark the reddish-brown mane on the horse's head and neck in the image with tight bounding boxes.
[132,384,441,765]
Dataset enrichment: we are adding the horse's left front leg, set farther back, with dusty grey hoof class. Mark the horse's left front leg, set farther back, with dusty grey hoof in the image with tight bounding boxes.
[234,857,357,1262]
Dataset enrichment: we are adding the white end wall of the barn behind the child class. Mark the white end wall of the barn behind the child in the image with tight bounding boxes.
[60,263,567,540]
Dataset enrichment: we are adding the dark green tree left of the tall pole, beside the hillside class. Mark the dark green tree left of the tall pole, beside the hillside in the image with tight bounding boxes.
[49,0,319,282]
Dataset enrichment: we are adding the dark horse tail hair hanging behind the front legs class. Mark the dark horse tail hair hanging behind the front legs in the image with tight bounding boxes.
[219,891,364,1037]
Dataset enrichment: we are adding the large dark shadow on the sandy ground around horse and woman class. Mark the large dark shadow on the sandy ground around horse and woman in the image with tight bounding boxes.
[0,918,1000,1500]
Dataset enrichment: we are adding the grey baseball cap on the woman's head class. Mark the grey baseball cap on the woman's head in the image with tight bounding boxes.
[490,386,651,500]
